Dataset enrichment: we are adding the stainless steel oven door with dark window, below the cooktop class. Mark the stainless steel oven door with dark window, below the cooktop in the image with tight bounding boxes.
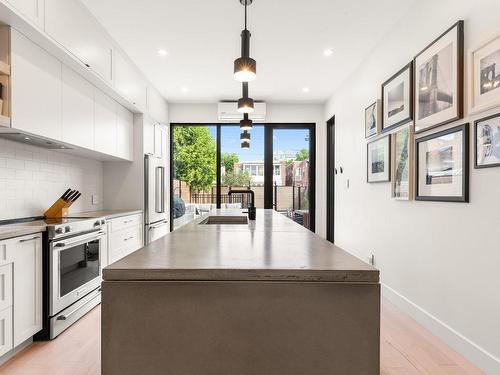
[50,230,107,320]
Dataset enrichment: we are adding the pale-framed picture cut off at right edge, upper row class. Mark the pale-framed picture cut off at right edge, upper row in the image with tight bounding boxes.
[470,36,500,113]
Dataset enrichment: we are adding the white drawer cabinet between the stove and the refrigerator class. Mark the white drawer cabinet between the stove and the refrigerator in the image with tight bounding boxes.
[108,214,144,264]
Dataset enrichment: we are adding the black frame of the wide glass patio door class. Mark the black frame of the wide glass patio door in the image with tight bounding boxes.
[169,123,316,232]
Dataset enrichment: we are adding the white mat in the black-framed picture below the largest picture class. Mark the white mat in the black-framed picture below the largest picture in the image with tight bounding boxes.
[417,130,464,197]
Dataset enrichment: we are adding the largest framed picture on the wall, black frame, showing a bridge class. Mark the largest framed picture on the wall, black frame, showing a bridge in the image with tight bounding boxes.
[414,21,464,133]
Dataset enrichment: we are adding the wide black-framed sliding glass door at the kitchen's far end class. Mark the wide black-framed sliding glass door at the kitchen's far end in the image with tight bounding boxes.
[170,124,315,231]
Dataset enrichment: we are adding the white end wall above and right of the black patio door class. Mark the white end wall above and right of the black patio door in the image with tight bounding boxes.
[169,103,326,237]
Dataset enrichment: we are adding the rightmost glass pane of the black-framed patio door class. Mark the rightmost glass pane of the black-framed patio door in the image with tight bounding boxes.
[273,128,311,228]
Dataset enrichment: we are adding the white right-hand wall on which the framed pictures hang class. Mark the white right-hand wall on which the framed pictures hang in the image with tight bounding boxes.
[324,0,500,374]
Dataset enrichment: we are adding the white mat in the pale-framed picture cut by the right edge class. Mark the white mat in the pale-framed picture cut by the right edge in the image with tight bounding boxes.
[470,36,500,113]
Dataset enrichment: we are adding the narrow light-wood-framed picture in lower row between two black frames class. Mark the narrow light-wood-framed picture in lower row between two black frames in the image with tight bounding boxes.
[391,126,413,200]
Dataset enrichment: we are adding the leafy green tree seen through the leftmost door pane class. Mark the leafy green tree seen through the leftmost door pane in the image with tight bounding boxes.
[173,126,216,192]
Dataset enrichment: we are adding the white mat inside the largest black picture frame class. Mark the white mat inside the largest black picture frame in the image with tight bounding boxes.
[415,25,458,131]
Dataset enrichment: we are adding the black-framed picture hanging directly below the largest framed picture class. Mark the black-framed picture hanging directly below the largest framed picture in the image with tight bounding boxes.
[415,124,469,202]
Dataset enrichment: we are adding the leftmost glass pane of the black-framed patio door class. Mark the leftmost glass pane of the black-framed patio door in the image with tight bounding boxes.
[171,125,217,230]
